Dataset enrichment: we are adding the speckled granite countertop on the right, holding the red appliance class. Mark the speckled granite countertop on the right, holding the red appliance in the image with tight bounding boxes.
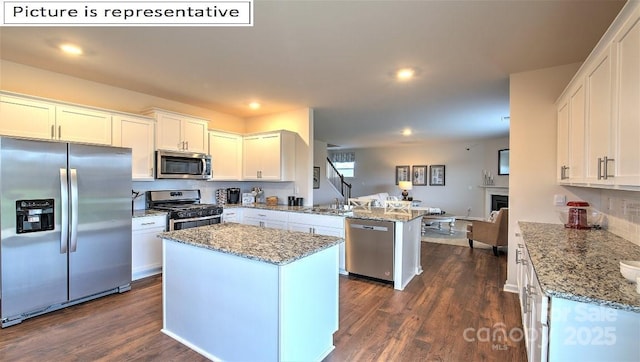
[518,221,640,313]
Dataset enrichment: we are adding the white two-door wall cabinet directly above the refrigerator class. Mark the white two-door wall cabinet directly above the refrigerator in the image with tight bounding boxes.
[0,94,111,145]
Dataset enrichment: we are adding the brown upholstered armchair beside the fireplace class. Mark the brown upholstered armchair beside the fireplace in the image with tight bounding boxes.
[467,207,509,256]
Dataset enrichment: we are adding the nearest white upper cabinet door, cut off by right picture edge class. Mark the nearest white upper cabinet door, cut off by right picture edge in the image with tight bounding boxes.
[610,7,640,186]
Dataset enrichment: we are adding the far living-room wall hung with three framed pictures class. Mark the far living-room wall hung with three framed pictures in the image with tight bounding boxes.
[328,137,509,216]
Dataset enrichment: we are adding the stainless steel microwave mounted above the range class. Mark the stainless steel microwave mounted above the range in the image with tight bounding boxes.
[156,150,211,180]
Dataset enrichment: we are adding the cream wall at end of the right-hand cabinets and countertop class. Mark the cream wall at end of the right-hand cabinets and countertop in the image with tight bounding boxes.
[505,63,600,289]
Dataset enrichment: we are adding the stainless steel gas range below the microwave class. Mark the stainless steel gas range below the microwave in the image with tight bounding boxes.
[146,190,222,231]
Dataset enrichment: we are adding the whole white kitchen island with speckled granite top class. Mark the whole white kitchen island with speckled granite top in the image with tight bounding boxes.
[161,223,342,361]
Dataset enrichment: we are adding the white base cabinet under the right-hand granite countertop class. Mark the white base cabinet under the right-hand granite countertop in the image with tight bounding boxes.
[516,239,640,362]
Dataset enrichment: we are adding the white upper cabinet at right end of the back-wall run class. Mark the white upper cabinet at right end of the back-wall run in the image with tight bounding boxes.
[242,131,296,181]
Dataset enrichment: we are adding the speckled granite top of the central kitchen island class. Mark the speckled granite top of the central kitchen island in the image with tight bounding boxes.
[160,223,344,265]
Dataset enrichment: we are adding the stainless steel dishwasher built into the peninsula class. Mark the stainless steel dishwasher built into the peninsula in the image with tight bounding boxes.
[345,218,395,281]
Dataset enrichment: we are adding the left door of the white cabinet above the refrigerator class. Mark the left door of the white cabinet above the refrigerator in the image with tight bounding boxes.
[0,95,56,139]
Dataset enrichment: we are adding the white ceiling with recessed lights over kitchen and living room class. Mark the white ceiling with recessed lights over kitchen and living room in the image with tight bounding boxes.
[0,0,624,147]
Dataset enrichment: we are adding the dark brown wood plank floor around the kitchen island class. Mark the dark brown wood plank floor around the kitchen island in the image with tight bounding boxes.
[0,243,526,362]
